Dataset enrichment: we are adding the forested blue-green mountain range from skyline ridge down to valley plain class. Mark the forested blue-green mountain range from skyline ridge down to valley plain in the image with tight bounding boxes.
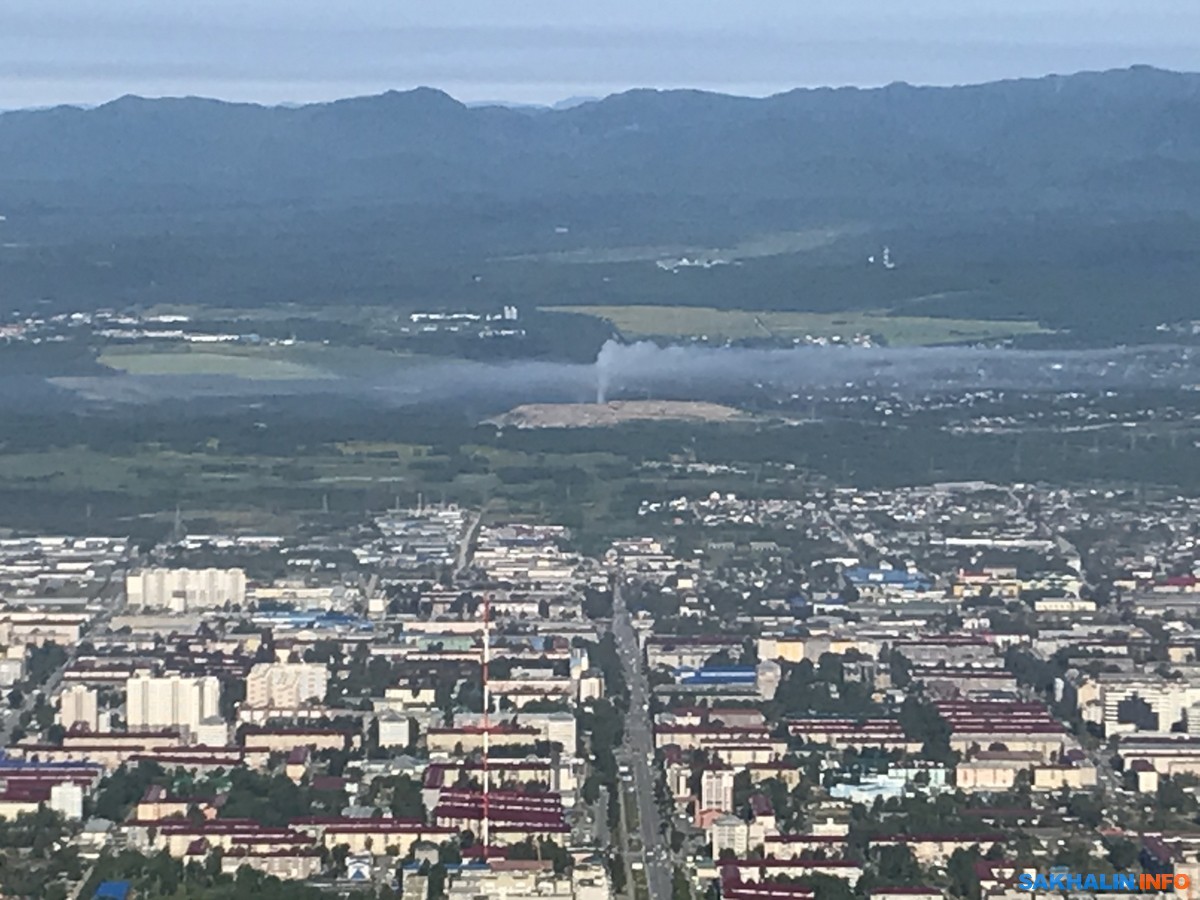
[0,68,1200,341]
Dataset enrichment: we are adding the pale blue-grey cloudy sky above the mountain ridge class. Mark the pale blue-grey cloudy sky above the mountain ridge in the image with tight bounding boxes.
[0,0,1200,109]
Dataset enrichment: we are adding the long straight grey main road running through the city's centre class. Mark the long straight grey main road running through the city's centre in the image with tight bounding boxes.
[612,574,673,900]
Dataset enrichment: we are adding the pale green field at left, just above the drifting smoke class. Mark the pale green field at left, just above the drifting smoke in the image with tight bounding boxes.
[100,346,331,382]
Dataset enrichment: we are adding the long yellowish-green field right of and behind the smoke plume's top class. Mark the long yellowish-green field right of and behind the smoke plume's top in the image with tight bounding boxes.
[546,306,1046,347]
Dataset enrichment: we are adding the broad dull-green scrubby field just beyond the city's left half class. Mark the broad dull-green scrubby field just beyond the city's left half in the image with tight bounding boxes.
[0,436,648,542]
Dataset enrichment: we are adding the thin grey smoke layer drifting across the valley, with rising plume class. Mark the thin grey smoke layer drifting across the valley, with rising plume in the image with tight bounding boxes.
[44,342,1200,409]
